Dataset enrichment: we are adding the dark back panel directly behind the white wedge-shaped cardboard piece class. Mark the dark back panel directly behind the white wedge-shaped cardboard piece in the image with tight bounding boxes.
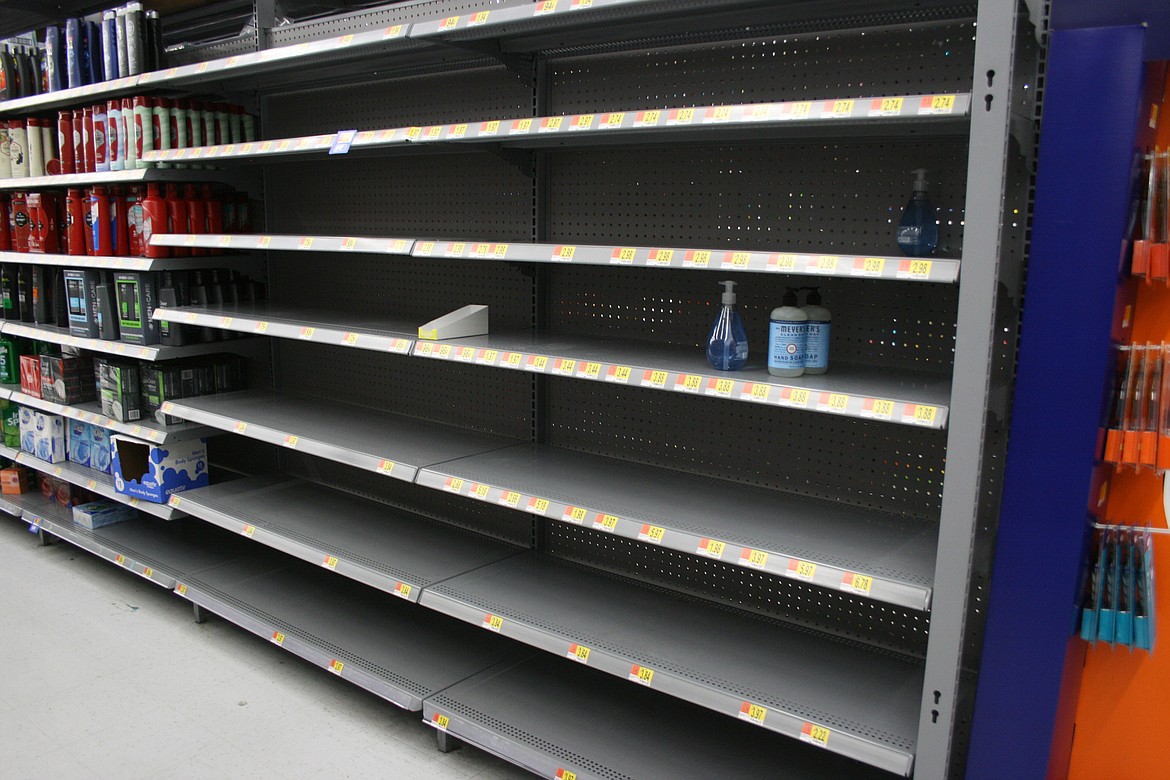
[270,253,532,331]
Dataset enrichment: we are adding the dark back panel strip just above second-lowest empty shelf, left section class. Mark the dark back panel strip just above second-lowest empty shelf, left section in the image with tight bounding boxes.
[281,448,532,547]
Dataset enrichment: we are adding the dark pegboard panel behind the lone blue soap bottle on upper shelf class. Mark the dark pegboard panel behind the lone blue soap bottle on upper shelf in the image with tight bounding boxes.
[549,138,966,257]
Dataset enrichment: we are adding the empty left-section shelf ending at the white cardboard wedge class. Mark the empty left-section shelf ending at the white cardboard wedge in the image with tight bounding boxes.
[153,303,419,354]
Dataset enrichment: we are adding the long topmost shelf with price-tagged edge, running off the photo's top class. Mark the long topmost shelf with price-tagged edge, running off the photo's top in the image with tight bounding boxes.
[0,0,978,115]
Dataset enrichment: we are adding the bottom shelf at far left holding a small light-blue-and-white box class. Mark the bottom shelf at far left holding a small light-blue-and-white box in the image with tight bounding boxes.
[7,493,240,588]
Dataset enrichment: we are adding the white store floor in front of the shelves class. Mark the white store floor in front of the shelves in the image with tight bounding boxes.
[0,513,532,780]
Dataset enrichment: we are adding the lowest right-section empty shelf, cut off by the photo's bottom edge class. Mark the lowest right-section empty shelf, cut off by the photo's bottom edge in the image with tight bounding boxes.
[422,655,889,780]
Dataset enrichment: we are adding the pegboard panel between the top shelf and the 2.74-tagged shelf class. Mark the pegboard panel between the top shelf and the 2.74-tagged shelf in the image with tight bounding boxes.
[550,22,975,113]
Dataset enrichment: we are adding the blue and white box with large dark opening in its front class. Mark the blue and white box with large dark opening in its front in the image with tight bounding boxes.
[110,434,211,504]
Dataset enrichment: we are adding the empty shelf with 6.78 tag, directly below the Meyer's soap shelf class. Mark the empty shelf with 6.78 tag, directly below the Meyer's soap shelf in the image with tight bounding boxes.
[417,446,937,609]
